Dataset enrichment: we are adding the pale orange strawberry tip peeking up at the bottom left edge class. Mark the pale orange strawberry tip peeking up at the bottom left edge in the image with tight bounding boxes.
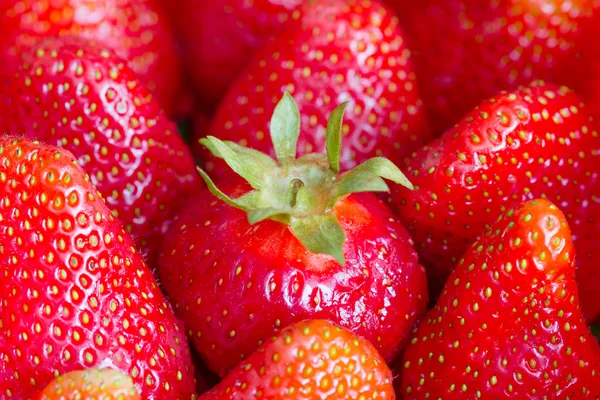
[33,369,141,400]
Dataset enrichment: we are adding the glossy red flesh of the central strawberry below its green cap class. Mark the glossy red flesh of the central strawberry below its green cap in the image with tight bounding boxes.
[159,188,427,376]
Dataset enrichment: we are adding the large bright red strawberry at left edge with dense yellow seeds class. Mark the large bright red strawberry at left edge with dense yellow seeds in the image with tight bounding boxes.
[0,136,194,400]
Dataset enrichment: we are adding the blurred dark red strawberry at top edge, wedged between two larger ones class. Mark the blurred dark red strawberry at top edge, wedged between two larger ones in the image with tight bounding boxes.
[171,0,304,109]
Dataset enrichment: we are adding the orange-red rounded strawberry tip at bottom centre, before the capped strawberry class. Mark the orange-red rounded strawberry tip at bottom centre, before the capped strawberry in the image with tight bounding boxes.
[200,320,395,400]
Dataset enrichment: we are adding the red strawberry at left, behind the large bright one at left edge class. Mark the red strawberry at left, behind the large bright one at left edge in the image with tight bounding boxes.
[0,38,201,263]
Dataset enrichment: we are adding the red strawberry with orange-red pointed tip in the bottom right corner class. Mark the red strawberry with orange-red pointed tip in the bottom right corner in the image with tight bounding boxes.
[402,200,600,400]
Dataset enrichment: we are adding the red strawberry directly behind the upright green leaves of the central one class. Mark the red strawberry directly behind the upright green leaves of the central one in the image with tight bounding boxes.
[201,0,430,181]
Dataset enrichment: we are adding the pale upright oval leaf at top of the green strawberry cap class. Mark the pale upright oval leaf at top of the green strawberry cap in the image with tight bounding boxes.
[270,92,300,165]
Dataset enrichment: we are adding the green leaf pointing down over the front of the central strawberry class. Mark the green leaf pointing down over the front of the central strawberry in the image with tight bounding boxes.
[290,213,346,265]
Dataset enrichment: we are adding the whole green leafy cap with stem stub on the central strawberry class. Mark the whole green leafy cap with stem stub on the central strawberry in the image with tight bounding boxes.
[198,93,413,265]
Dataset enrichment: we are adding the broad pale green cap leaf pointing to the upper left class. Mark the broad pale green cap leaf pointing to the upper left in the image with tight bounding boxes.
[200,136,277,190]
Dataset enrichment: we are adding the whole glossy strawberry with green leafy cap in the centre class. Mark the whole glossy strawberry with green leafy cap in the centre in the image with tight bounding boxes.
[159,94,427,376]
